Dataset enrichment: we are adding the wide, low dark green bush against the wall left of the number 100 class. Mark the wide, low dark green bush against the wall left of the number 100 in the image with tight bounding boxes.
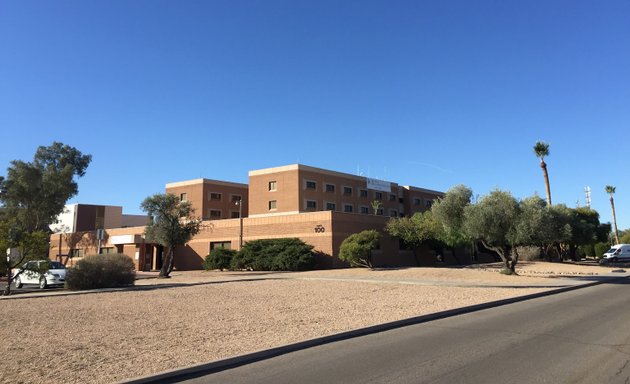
[231,238,315,271]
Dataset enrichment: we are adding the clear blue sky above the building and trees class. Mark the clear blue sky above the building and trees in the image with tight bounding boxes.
[0,0,630,229]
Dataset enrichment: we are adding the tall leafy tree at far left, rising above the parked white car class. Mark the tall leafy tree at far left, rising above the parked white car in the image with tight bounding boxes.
[0,142,92,294]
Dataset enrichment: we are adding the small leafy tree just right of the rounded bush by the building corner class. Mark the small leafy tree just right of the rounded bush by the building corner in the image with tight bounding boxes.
[385,211,443,266]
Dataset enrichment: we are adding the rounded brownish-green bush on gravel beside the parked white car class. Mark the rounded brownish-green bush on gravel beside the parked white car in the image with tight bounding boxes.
[66,253,136,290]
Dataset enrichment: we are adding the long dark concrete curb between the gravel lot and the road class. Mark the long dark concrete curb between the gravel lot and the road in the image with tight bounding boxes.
[118,276,628,384]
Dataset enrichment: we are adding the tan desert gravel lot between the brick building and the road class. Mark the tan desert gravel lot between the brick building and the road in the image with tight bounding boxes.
[0,263,610,384]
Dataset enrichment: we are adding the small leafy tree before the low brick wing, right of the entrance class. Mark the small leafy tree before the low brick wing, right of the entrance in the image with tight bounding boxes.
[140,194,201,277]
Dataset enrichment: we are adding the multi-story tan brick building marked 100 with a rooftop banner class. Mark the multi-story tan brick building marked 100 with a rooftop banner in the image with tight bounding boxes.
[50,164,488,270]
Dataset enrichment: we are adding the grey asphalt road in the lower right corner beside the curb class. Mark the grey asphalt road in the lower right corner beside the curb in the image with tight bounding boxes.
[178,279,630,384]
